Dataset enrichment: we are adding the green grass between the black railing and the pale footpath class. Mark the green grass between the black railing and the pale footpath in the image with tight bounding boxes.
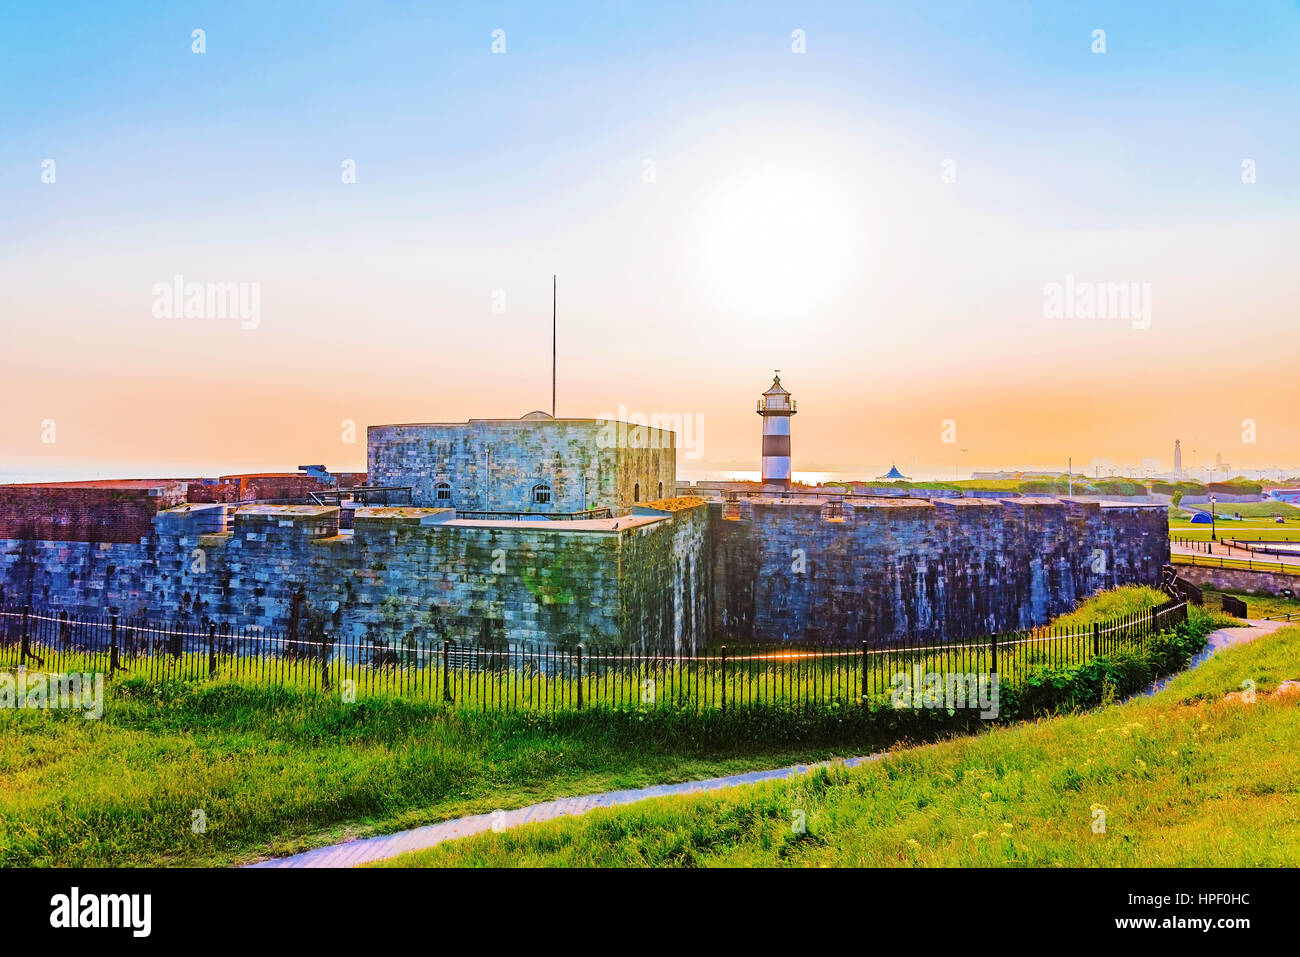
[0,589,1210,866]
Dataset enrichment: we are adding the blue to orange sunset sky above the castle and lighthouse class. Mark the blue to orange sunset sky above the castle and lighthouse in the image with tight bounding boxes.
[0,0,1300,477]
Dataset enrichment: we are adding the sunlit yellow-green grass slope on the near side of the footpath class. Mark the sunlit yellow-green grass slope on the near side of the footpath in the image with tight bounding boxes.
[389,627,1300,867]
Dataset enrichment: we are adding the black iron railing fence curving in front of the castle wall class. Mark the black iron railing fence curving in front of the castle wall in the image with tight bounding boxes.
[0,601,1187,711]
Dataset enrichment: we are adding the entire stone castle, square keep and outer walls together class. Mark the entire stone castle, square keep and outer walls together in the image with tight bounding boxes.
[0,382,1169,649]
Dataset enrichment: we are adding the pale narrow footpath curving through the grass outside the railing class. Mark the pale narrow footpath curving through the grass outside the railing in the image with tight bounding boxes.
[247,622,1286,867]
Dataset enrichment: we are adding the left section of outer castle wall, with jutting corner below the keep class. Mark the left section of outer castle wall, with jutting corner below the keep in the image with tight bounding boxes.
[0,506,707,648]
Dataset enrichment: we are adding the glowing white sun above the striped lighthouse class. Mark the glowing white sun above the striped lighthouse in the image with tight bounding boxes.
[692,168,865,319]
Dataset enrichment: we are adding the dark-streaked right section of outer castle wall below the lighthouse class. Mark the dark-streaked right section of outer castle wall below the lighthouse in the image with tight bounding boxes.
[710,499,1169,642]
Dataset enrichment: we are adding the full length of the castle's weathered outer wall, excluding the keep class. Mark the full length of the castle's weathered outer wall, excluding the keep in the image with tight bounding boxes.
[0,498,1169,649]
